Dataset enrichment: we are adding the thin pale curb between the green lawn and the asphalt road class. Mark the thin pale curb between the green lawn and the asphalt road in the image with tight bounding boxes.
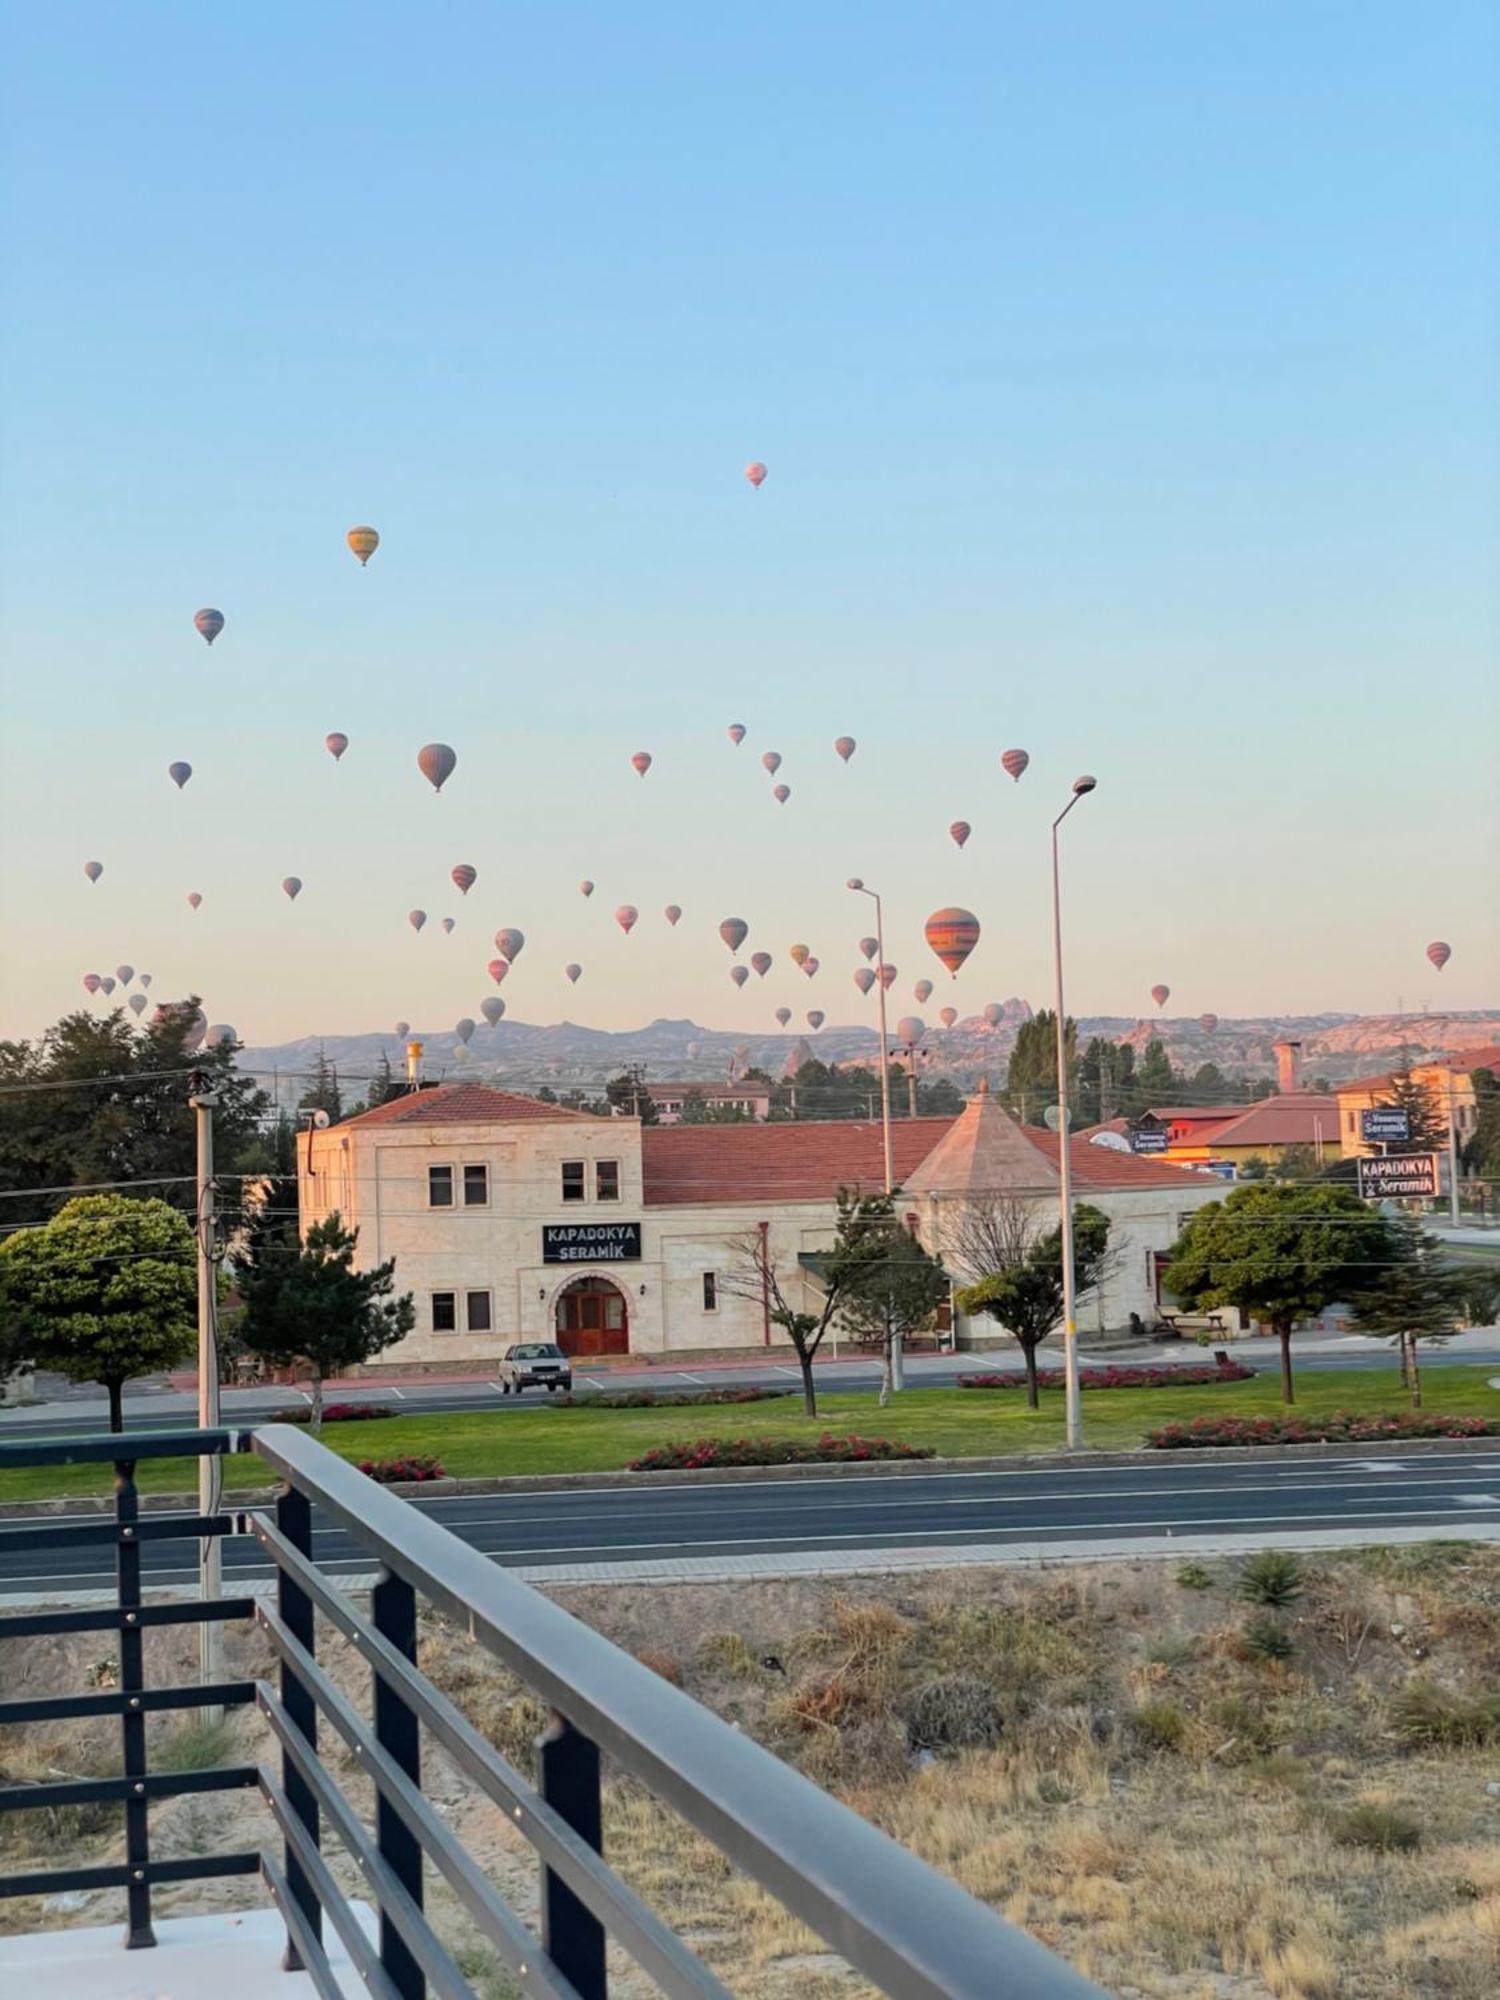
[0,1438,1500,1520]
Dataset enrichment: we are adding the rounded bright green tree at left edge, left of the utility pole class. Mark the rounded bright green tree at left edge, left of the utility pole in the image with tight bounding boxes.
[0,1194,198,1430]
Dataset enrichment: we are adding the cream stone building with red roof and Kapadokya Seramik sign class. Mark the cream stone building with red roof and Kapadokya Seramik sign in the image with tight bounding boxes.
[298,1082,1222,1368]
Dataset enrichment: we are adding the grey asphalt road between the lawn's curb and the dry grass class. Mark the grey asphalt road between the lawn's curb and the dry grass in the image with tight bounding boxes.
[0,1448,1500,1594]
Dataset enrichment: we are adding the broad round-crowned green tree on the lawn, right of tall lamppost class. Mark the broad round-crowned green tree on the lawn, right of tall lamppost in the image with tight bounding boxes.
[1164,1180,1388,1402]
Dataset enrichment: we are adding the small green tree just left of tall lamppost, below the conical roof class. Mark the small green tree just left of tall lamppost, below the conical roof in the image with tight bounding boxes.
[950,1194,1110,1410]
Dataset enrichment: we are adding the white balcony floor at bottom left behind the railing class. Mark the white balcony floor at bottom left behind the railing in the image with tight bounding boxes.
[0,1904,374,2000]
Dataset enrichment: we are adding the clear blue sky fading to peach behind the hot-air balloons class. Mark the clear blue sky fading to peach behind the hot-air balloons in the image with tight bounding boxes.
[0,0,1500,1044]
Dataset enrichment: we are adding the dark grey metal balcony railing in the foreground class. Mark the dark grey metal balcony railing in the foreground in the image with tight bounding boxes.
[0,1424,1098,2000]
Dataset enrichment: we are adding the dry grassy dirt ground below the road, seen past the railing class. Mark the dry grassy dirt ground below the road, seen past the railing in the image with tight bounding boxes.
[0,1544,1500,2000]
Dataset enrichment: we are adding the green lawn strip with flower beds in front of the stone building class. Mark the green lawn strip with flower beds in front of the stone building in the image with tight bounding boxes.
[0,1364,1500,1500]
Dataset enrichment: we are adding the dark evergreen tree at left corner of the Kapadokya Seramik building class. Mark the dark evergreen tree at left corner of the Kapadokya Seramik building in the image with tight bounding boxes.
[240,1210,416,1430]
